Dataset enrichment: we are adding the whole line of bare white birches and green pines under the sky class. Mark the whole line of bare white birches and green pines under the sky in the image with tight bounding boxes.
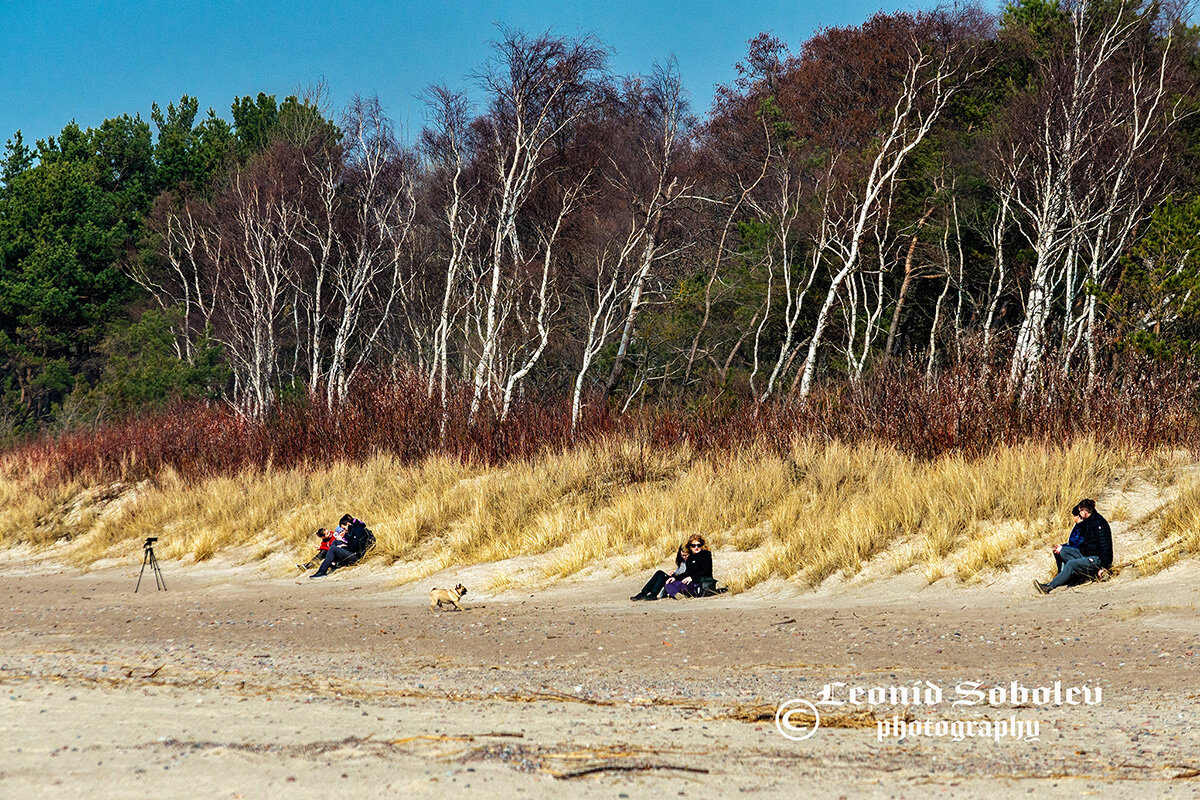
[0,0,1200,437]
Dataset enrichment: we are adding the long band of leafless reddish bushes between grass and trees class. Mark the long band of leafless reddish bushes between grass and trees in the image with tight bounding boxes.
[16,356,1200,479]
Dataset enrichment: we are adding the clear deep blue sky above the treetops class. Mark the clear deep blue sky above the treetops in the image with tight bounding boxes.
[0,0,998,148]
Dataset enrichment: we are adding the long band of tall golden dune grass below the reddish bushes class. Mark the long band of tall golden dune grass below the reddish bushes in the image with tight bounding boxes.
[0,438,1142,591]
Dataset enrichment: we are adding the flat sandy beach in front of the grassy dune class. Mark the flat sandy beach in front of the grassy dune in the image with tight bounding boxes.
[0,552,1200,799]
